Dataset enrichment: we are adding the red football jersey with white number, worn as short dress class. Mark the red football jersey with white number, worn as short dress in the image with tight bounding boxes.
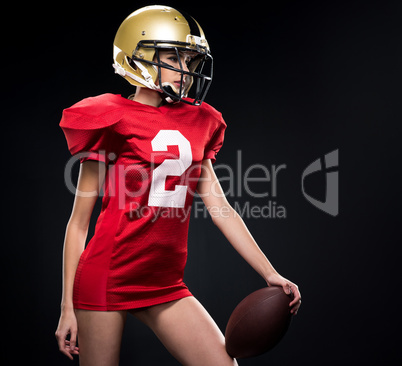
[60,94,226,310]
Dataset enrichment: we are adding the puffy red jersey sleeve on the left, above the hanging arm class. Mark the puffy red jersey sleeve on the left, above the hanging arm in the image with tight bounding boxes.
[60,101,118,164]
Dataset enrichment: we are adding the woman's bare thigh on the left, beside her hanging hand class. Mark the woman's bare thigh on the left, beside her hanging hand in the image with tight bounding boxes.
[75,310,127,366]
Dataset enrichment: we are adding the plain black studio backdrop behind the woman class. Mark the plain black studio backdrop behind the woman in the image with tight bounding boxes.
[2,1,402,366]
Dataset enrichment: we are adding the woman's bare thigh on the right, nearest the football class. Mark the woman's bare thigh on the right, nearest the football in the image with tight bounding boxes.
[131,296,237,366]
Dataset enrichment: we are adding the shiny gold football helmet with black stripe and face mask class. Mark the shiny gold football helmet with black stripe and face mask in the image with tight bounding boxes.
[113,5,213,105]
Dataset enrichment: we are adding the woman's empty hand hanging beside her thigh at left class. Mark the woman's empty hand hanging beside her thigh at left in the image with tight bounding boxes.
[55,309,79,360]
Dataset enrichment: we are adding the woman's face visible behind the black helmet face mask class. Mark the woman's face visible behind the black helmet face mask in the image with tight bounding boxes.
[156,49,193,93]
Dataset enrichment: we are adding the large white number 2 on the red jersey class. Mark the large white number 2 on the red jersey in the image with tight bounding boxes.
[148,130,193,207]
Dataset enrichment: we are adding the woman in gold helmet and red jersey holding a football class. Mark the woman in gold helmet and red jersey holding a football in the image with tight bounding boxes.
[56,6,300,366]
